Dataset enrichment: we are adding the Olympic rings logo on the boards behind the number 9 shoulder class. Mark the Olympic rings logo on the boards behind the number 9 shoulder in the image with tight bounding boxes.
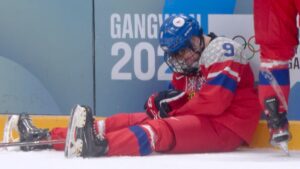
[232,35,260,60]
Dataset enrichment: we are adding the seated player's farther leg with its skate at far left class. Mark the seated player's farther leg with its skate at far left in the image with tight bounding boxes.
[4,113,148,151]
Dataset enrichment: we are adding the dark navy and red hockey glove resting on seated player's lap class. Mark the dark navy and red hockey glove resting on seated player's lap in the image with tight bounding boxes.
[144,89,188,119]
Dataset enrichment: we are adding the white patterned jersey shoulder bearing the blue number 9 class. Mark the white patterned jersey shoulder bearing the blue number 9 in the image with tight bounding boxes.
[200,37,246,67]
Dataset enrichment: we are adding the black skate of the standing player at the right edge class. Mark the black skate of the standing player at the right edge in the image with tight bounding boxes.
[265,98,291,155]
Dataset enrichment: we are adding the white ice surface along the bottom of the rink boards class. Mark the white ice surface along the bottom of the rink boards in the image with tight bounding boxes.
[0,149,300,169]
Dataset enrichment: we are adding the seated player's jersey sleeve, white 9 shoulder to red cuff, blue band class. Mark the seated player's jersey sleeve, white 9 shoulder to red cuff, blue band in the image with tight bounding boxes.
[172,37,247,115]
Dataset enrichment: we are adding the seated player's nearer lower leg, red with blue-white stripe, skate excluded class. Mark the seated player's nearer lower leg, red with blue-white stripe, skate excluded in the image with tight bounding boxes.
[106,119,175,156]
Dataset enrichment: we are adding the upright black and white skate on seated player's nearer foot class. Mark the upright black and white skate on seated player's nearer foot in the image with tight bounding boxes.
[65,105,107,158]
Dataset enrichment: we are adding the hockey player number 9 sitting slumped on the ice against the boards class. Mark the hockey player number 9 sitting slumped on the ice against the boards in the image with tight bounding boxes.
[2,15,260,157]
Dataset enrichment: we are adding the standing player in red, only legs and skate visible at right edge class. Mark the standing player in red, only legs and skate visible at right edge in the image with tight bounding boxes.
[254,0,300,152]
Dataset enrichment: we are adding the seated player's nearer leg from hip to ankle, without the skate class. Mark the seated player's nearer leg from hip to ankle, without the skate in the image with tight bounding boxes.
[106,115,243,156]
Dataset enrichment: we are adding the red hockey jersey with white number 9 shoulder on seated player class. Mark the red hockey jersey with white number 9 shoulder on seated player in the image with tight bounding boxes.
[172,37,260,143]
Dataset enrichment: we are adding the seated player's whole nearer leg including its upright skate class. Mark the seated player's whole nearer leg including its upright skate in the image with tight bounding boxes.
[65,107,243,157]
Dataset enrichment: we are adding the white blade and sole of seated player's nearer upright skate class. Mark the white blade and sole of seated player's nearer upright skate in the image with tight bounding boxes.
[65,105,86,158]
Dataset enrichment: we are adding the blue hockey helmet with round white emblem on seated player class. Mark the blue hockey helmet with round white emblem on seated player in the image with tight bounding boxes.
[159,14,203,55]
